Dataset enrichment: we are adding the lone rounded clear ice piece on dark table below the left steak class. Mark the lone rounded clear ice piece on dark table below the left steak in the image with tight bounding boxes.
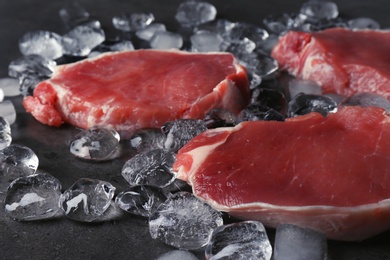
[70,128,120,161]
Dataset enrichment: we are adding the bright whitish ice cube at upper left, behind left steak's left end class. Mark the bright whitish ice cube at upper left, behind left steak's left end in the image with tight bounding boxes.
[19,31,63,60]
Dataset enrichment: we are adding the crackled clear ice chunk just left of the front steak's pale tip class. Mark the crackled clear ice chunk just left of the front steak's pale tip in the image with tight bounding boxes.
[122,149,176,188]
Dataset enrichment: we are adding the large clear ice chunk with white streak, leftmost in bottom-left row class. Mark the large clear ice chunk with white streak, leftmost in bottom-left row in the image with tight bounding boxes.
[4,172,61,221]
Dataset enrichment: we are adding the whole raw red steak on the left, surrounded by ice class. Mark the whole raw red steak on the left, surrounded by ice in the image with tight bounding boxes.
[23,50,249,138]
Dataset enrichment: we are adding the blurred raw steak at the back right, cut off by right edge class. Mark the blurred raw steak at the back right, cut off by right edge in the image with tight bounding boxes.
[272,28,390,99]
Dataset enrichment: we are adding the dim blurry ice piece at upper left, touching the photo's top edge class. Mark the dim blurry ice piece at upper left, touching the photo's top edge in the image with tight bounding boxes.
[59,0,90,29]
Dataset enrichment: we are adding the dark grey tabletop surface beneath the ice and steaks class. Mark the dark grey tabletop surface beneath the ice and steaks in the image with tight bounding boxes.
[0,0,390,260]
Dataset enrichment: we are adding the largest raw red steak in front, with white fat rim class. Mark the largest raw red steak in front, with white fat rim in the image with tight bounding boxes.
[173,107,390,240]
